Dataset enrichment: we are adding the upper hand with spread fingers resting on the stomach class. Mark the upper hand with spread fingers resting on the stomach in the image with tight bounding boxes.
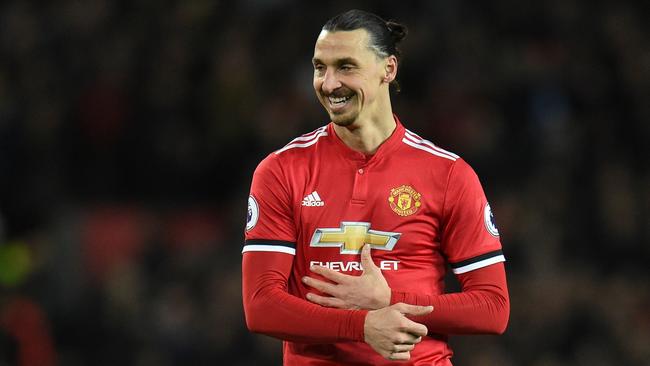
[302,244,391,310]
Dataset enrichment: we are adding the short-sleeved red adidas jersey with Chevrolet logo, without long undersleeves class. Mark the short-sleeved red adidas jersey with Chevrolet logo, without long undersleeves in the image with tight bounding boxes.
[243,118,505,365]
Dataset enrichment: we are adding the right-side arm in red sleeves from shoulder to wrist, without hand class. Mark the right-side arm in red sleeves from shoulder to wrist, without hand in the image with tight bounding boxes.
[422,159,510,334]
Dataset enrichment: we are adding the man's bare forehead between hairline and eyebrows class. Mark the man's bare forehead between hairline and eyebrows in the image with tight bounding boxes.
[314,29,372,61]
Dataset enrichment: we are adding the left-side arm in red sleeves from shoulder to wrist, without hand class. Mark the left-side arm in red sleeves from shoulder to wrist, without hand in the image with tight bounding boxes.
[242,154,367,343]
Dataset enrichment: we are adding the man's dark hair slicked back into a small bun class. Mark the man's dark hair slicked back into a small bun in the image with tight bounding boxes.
[323,9,408,92]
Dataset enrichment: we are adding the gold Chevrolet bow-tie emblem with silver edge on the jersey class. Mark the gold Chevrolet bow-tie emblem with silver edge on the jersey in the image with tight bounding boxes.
[309,221,402,254]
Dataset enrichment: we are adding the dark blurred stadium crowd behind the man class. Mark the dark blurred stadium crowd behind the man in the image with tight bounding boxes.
[0,0,650,366]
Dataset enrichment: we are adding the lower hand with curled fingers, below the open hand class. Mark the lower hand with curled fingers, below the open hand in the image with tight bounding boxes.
[363,303,433,361]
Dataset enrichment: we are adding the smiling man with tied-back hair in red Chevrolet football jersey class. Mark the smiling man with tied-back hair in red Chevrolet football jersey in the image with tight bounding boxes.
[242,10,509,365]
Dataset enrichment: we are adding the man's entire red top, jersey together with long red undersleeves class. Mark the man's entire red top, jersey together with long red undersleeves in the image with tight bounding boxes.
[243,119,509,365]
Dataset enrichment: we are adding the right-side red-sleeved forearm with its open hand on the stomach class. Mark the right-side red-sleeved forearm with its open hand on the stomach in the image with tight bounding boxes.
[303,245,510,334]
